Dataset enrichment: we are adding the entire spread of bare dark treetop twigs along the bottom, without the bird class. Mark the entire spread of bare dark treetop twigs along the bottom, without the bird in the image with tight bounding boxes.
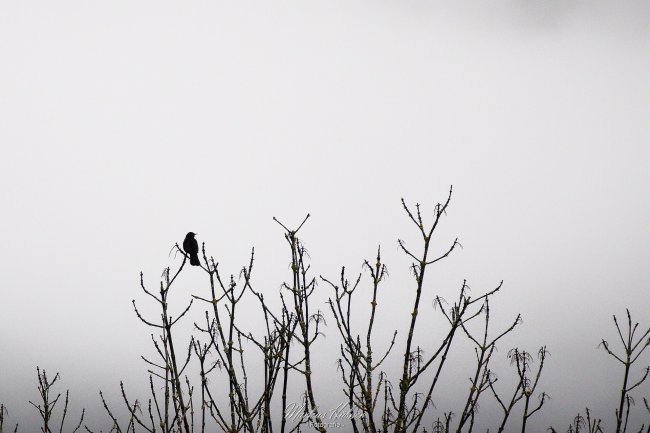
[0,190,650,433]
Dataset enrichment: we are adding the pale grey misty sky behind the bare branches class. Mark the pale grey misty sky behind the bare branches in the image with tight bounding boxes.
[0,0,650,426]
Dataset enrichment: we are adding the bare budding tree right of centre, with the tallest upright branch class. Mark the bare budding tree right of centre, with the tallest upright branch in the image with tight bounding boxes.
[321,190,520,433]
